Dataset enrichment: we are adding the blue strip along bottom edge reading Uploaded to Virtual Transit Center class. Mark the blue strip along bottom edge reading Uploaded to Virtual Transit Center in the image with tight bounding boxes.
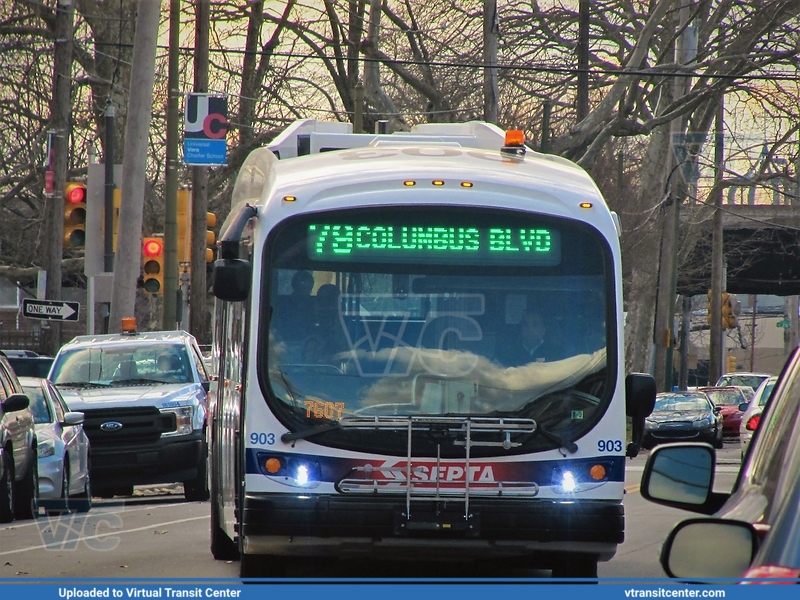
[0,579,800,600]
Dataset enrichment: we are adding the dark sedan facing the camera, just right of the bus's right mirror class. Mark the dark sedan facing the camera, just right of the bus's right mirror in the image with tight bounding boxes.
[642,392,722,448]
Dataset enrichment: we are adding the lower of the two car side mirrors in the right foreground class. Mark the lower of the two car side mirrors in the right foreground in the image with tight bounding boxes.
[661,519,758,582]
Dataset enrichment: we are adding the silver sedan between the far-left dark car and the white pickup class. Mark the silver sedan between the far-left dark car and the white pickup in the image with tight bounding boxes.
[19,377,92,511]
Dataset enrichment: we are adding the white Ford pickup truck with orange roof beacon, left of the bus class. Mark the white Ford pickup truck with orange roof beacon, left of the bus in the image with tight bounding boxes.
[49,331,209,501]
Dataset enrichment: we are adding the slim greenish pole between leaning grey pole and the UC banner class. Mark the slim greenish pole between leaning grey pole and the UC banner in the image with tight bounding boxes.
[162,0,180,331]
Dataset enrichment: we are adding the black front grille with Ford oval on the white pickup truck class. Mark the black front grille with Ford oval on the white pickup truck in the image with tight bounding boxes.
[82,406,175,448]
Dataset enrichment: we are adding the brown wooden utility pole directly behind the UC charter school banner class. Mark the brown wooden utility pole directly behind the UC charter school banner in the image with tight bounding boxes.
[189,0,211,344]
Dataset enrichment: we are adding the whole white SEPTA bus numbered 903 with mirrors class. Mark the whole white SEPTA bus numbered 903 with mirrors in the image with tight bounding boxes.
[210,120,655,577]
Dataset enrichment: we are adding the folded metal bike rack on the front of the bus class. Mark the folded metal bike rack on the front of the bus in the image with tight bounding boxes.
[336,416,539,530]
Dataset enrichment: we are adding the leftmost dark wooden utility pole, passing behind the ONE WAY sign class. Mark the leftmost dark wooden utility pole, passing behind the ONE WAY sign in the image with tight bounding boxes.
[41,0,75,356]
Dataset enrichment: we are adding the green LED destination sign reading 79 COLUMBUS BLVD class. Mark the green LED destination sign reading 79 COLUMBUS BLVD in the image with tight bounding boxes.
[308,224,561,266]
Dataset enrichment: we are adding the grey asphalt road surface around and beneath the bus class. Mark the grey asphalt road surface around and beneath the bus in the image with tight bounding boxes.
[0,441,739,579]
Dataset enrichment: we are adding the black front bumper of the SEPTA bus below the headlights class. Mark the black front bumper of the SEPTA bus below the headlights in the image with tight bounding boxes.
[240,494,625,561]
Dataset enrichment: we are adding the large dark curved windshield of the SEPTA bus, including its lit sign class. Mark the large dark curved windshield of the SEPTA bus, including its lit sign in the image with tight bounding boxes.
[259,207,617,450]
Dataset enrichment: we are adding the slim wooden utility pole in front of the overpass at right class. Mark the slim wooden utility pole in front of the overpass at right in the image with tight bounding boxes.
[708,97,725,385]
